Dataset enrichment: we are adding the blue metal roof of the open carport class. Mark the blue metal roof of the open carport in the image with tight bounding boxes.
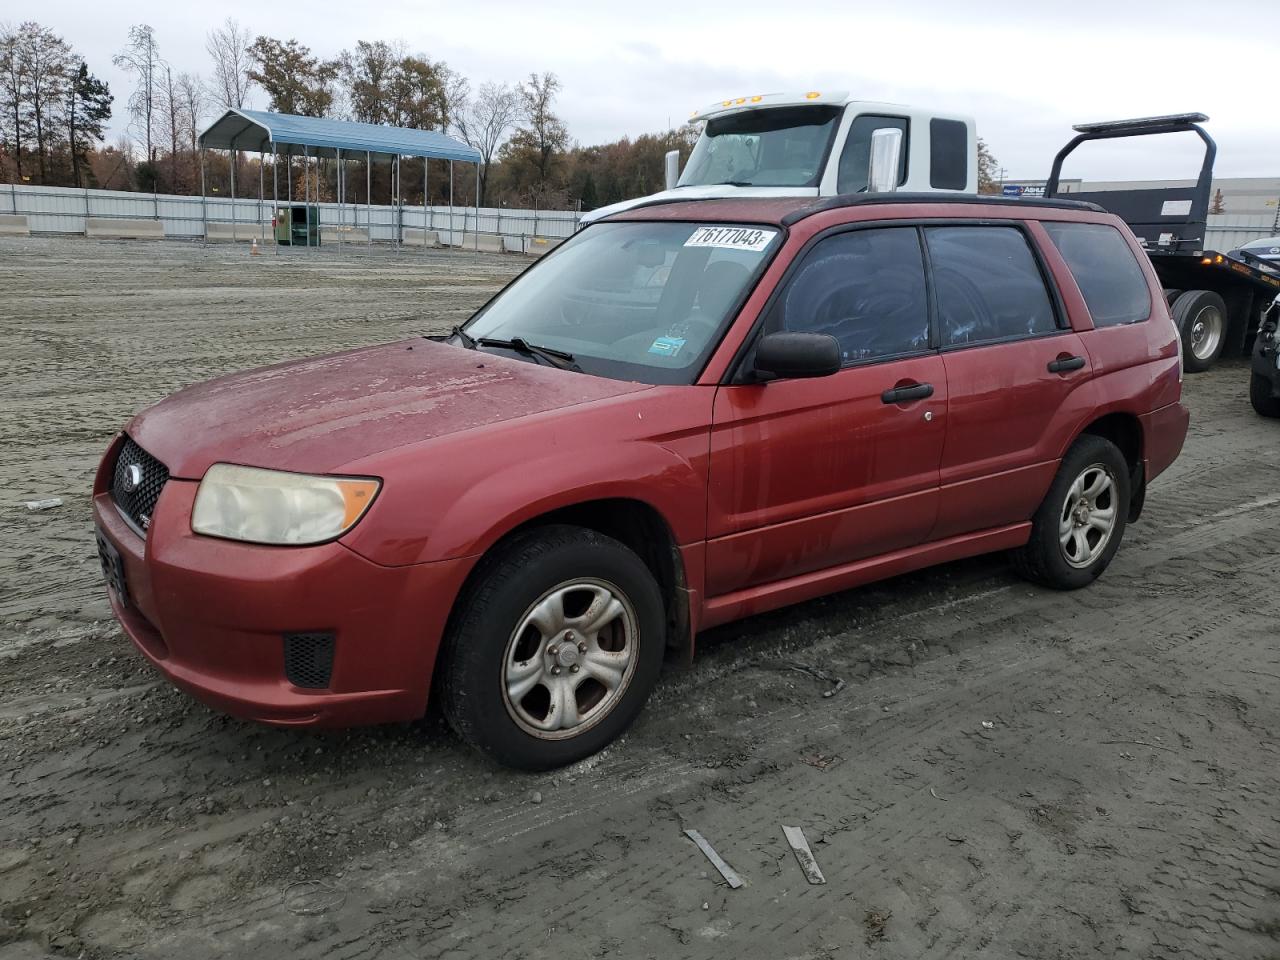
[200,110,480,164]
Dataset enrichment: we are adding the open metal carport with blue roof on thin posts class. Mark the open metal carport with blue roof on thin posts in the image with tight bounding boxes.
[200,110,480,250]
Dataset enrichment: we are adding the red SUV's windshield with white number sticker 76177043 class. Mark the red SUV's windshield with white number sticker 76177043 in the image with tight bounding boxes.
[463,223,781,384]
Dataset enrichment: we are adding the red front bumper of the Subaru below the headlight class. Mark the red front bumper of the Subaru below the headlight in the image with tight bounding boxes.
[93,445,471,726]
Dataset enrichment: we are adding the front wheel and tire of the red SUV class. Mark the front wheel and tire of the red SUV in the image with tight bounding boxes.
[439,525,666,771]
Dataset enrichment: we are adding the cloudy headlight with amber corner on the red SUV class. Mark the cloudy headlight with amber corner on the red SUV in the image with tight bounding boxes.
[191,463,381,544]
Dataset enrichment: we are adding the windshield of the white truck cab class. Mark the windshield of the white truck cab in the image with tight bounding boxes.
[680,106,840,187]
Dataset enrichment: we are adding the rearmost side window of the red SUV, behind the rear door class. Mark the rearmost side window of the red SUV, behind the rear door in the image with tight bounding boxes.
[1042,220,1151,326]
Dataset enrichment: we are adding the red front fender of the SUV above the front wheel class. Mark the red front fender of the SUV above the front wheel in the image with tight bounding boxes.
[343,388,714,566]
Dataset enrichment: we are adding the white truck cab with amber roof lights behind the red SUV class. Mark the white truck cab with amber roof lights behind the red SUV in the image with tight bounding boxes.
[582,91,978,223]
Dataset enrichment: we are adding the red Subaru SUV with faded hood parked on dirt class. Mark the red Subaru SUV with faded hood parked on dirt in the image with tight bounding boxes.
[93,195,1188,768]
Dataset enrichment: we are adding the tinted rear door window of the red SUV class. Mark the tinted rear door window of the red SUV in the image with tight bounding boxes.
[924,227,1057,347]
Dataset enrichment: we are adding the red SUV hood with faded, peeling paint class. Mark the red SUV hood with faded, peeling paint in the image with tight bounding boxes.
[128,339,648,480]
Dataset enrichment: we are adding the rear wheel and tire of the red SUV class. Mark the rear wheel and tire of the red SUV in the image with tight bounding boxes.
[1012,434,1130,590]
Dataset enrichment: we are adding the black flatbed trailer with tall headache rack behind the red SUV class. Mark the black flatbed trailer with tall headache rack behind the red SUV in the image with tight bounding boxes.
[1044,114,1280,372]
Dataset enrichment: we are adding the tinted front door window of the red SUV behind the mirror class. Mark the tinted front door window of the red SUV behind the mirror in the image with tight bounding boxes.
[765,227,929,364]
